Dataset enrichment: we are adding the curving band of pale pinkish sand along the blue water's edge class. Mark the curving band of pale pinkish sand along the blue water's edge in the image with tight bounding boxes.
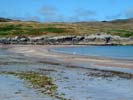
[1,45,133,73]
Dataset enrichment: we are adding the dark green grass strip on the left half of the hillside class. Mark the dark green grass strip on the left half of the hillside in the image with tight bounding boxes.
[0,25,67,36]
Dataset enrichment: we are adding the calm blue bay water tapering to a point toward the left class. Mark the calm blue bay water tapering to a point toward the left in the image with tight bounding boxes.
[53,46,133,60]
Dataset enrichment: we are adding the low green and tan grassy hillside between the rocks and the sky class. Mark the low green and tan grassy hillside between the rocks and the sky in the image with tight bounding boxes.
[0,18,133,37]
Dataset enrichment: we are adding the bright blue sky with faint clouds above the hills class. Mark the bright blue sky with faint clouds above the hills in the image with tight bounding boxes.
[0,0,133,22]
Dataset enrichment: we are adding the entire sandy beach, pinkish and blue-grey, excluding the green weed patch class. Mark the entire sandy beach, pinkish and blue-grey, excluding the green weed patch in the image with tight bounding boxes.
[0,45,133,100]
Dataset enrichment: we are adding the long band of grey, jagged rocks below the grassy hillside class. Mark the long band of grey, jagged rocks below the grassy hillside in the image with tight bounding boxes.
[0,34,133,45]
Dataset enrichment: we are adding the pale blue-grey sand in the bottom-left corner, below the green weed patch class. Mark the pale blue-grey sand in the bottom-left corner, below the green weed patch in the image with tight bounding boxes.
[0,75,55,100]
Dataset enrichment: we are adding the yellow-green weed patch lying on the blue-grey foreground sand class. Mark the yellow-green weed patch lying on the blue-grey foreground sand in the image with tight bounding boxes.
[1,72,57,94]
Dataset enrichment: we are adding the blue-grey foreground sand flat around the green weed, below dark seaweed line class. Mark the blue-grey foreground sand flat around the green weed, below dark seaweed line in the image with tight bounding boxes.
[0,47,133,100]
